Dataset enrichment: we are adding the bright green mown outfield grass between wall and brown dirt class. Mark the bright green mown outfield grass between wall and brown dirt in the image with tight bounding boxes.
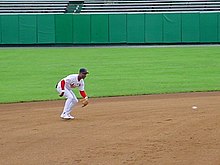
[0,46,220,103]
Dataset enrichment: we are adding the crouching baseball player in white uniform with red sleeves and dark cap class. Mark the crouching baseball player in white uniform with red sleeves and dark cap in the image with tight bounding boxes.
[56,68,89,119]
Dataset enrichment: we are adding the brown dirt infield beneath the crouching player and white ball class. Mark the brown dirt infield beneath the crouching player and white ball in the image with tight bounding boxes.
[0,92,220,165]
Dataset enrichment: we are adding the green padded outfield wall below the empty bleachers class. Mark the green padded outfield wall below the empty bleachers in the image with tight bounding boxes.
[0,13,220,44]
